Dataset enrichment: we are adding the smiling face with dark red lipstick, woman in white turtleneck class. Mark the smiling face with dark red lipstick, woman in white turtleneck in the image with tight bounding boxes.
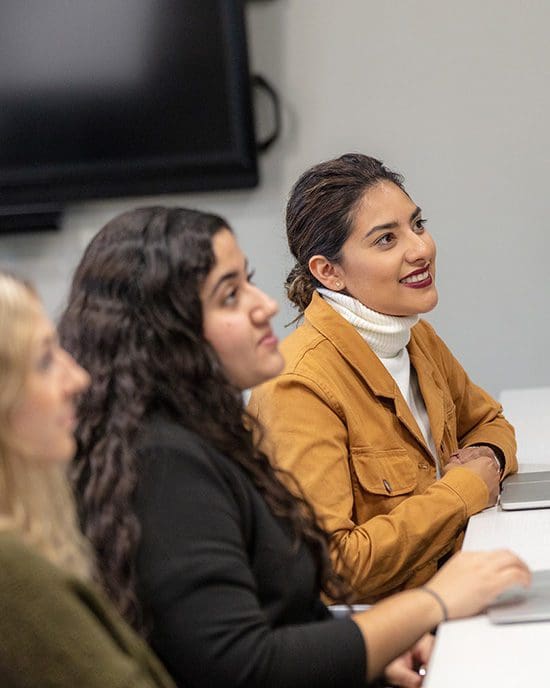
[329,181,438,316]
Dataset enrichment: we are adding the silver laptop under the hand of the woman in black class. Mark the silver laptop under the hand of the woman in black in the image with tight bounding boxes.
[487,569,550,624]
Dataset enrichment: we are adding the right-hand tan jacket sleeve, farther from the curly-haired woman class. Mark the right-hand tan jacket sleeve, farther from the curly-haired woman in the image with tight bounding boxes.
[423,322,518,476]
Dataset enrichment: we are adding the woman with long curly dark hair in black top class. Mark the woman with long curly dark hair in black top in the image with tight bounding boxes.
[60,207,529,688]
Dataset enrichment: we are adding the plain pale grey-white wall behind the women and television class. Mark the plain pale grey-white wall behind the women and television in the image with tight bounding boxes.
[0,0,550,394]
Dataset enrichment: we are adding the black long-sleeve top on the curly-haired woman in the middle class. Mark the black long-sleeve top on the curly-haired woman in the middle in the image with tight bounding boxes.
[135,416,366,688]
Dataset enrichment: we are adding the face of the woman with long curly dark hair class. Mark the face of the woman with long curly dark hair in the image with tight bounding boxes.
[201,229,283,390]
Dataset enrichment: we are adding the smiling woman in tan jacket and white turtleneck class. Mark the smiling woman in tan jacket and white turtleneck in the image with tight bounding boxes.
[249,154,517,602]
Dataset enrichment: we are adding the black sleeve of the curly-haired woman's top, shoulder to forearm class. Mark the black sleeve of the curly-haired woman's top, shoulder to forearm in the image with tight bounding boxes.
[137,446,366,688]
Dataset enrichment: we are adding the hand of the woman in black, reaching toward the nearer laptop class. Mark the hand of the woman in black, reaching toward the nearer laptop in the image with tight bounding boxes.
[424,549,531,619]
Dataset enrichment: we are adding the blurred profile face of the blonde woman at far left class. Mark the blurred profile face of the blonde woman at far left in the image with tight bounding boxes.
[10,305,89,464]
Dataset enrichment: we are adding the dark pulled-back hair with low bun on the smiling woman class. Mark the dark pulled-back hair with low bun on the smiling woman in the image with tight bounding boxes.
[285,153,405,313]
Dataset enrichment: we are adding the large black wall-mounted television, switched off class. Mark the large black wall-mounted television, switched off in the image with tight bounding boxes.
[0,0,258,230]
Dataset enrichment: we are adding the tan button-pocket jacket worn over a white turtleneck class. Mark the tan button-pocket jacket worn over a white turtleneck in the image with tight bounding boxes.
[249,294,517,602]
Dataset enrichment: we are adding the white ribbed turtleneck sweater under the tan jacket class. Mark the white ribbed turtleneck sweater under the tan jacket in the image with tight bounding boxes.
[317,288,441,478]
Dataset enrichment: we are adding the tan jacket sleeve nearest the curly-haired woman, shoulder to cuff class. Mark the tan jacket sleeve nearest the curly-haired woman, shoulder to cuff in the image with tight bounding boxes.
[249,373,488,600]
